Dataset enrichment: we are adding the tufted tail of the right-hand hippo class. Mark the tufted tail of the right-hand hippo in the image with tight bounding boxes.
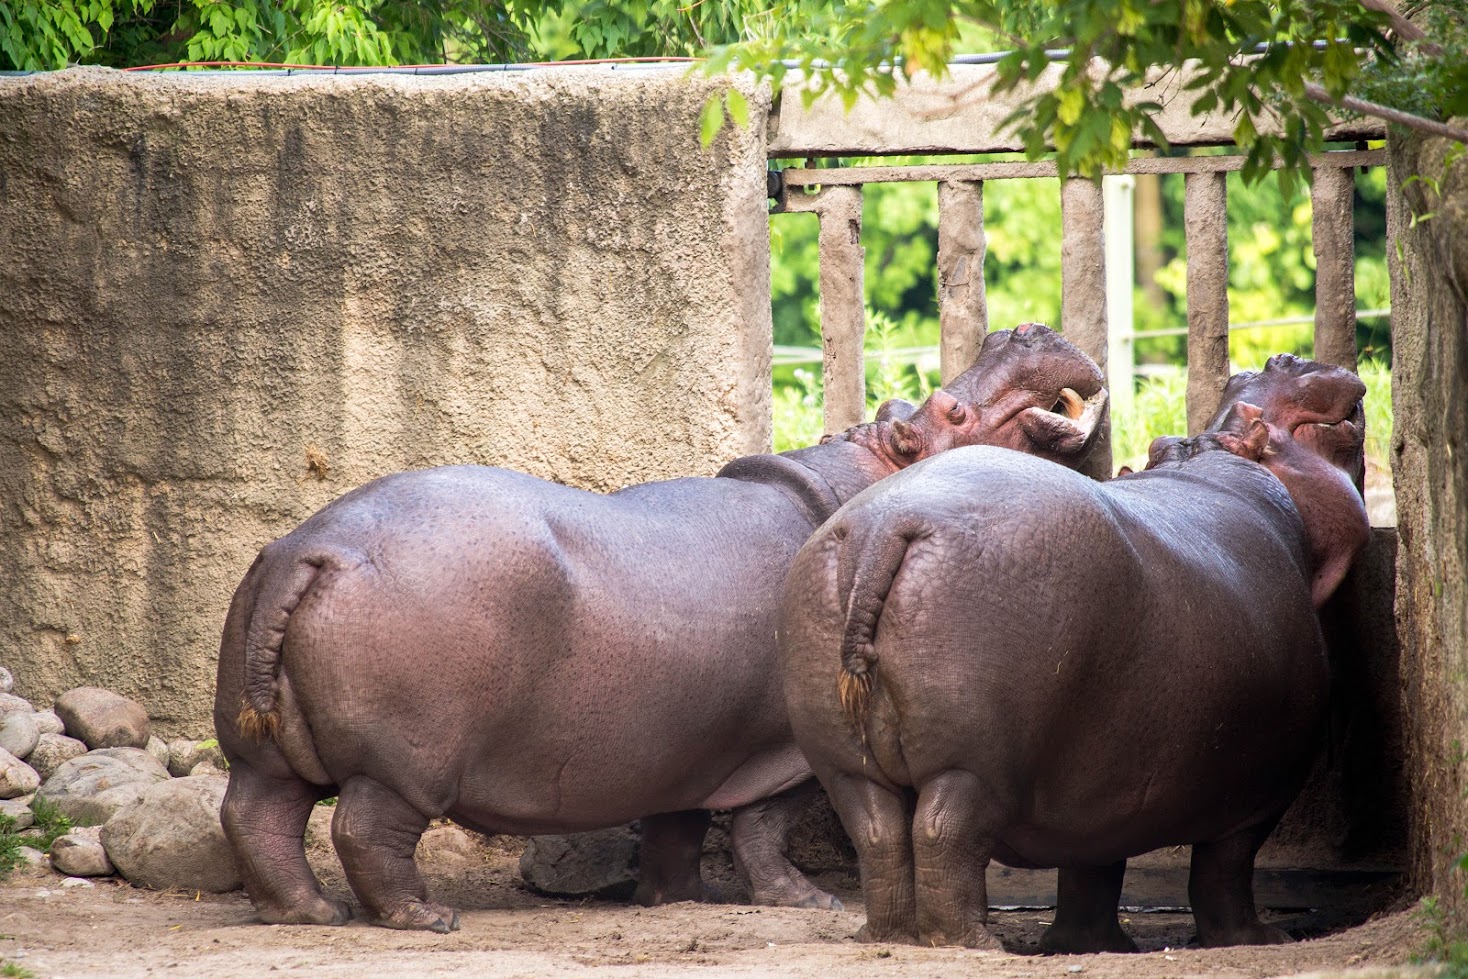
[837,518,928,730]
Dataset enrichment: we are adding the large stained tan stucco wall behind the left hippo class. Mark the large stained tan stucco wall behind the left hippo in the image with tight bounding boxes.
[0,69,771,734]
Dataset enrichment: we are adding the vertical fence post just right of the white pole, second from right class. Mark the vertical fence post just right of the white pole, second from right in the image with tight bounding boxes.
[1183,173,1229,434]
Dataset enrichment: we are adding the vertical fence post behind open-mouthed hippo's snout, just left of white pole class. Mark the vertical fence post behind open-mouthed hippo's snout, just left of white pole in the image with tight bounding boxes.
[1060,178,1111,478]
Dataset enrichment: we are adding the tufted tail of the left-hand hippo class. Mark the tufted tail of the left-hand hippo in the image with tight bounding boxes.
[235,547,355,741]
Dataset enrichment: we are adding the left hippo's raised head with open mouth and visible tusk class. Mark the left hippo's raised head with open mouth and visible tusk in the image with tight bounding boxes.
[835,323,1107,467]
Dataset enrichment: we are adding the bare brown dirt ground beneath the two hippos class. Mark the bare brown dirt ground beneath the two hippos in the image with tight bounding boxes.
[0,813,1422,979]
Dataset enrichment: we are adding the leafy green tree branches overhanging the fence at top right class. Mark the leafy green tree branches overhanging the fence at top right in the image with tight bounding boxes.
[709,0,1468,179]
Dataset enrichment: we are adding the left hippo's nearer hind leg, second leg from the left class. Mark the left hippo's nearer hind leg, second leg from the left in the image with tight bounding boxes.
[332,775,459,933]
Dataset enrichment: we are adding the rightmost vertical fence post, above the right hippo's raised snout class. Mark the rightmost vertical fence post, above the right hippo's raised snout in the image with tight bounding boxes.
[1309,166,1356,370]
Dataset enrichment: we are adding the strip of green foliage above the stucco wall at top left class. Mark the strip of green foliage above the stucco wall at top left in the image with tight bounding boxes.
[0,0,760,70]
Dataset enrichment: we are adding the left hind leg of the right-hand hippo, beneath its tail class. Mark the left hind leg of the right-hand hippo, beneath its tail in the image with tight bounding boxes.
[822,774,918,942]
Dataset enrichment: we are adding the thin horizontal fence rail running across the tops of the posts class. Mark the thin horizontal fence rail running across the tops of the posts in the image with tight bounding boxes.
[780,150,1386,188]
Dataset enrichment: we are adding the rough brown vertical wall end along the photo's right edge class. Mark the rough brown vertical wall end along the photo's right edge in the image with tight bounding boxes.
[1387,129,1468,929]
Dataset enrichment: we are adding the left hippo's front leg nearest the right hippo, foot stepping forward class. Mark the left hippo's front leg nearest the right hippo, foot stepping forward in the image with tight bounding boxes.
[730,778,841,911]
